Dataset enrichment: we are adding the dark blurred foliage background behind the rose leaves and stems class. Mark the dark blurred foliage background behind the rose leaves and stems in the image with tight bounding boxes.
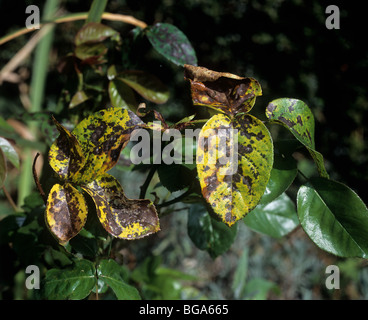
[0,0,368,299]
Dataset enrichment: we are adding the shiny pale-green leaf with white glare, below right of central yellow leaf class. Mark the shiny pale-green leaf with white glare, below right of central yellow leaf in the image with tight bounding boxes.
[243,193,299,238]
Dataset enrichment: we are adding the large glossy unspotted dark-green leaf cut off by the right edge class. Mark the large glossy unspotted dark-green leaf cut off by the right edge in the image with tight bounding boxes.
[297,178,368,258]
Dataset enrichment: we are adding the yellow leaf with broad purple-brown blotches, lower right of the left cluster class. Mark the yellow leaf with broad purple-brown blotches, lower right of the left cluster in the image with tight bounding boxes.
[83,174,160,240]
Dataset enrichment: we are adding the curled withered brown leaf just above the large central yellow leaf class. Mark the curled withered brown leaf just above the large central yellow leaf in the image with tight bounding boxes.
[184,64,262,115]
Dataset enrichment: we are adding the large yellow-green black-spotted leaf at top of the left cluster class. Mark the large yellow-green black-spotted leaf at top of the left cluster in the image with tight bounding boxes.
[71,108,143,184]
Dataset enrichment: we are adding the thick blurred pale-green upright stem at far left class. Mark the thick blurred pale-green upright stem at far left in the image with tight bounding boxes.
[18,0,59,207]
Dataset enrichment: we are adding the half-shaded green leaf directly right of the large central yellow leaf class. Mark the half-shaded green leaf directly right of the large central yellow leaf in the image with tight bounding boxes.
[259,140,300,204]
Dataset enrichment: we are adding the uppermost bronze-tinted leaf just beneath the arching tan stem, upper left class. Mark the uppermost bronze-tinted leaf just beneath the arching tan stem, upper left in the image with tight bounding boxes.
[74,22,119,46]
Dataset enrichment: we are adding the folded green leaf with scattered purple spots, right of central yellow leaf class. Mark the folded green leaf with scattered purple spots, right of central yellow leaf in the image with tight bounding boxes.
[266,98,328,178]
